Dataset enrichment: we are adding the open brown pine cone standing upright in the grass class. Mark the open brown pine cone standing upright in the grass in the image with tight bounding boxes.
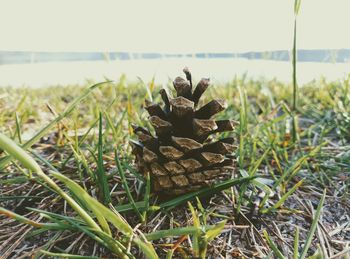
[131,68,237,195]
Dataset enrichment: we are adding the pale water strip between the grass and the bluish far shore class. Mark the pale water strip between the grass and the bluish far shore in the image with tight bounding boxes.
[0,58,350,87]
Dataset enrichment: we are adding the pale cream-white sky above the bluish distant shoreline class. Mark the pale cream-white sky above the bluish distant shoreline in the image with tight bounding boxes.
[0,0,350,53]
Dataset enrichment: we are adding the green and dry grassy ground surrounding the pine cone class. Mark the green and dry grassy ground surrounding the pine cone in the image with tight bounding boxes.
[0,77,350,258]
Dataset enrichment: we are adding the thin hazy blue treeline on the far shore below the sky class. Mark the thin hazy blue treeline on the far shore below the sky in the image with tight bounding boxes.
[0,49,350,64]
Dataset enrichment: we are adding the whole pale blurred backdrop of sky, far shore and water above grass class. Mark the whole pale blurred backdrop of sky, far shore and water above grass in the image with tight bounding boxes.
[0,0,350,87]
